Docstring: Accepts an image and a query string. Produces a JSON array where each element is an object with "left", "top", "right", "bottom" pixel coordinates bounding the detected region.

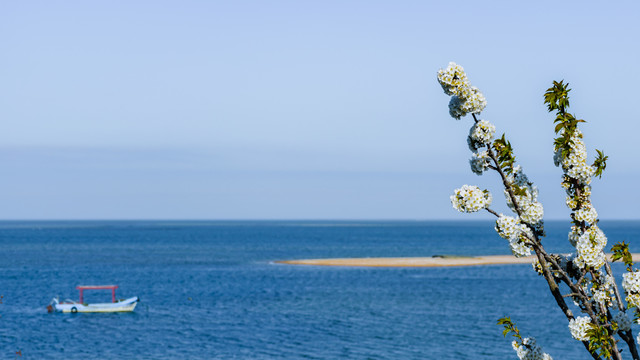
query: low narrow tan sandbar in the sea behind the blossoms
[{"left": 276, "top": 253, "right": 640, "bottom": 267}]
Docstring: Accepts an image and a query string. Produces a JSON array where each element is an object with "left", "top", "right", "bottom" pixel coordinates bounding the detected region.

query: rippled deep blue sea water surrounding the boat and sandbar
[{"left": 0, "top": 221, "right": 640, "bottom": 359}]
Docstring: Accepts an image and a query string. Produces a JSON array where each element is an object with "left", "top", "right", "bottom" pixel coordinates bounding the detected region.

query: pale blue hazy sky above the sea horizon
[{"left": 0, "top": 0, "right": 640, "bottom": 221}]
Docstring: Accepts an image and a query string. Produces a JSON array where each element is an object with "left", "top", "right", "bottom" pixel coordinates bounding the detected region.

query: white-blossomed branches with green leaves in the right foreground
[{"left": 438, "top": 63, "right": 640, "bottom": 360}]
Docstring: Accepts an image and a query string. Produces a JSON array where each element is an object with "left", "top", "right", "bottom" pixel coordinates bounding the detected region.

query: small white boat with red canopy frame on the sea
[{"left": 47, "top": 285, "right": 140, "bottom": 313}]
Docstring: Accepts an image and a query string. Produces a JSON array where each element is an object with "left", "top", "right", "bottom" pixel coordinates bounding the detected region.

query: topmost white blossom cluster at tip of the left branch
[{"left": 438, "top": 62, "right": 487, "bottom": 120}]
